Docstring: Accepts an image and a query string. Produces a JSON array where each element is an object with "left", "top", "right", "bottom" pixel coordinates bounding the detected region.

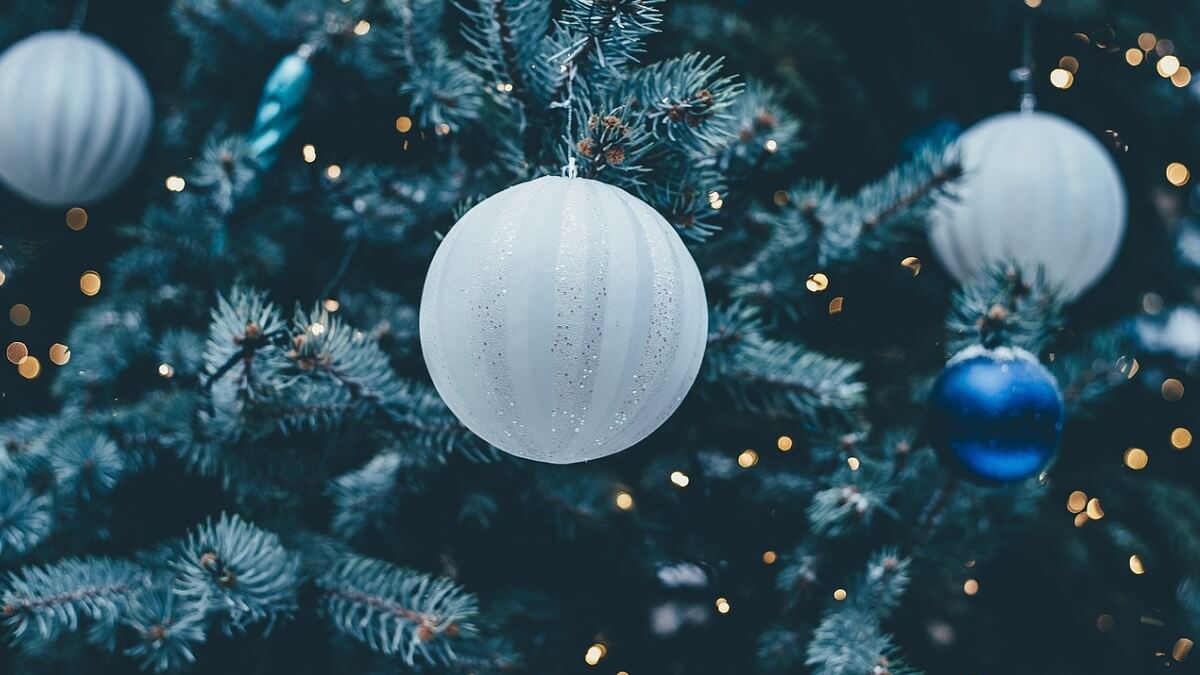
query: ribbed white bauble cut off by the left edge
[{"left": 0, "top": 30, "right": 152, "bottom": 207}]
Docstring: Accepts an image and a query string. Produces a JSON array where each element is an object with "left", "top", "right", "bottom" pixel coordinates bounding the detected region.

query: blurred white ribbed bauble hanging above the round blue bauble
[{"left": 930, "top": 110, "right": 1126, "bottom": 299}]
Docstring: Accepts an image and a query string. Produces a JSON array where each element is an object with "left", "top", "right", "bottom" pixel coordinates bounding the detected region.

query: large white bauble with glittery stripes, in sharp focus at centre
[{"left": 420, "top": 177, "right": 708, "bottom": 464}]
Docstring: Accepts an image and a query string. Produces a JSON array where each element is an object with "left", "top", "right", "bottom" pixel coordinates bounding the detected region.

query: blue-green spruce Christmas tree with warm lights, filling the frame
[{"left": 0, "top": 0, "right": 1200, "bottom": 675}]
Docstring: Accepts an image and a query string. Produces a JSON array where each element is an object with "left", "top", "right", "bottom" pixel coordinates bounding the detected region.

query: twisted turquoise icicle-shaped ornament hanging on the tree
[{"left": 247, "top": 44, "right": 312, "bottom": 168}]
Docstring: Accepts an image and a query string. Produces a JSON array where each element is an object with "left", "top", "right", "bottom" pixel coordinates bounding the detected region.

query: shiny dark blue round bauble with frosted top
[{"left": 926, "top": 347, "right": 1063, "bottom": 484}]
